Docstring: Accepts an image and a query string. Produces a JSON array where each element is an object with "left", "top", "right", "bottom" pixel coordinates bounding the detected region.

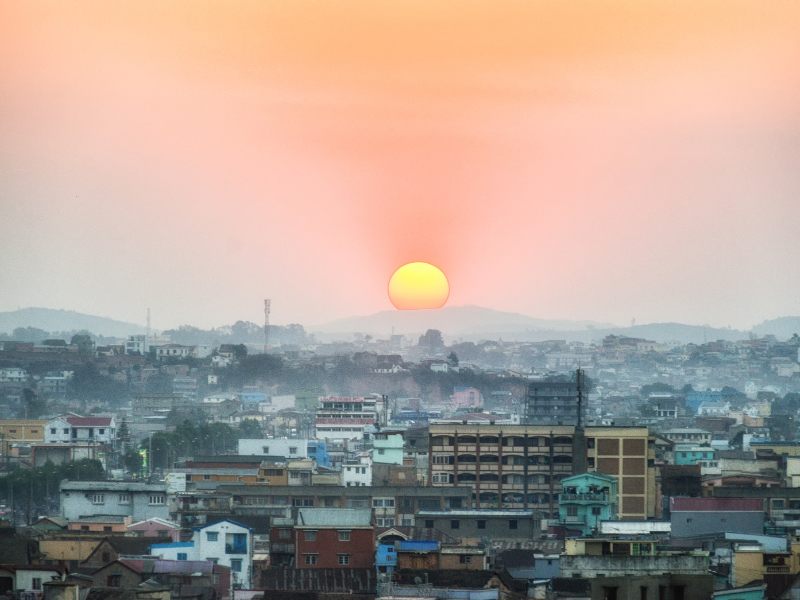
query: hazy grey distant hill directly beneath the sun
[{"left": 307, "top": 306, "right": 614, "bottom": 339}]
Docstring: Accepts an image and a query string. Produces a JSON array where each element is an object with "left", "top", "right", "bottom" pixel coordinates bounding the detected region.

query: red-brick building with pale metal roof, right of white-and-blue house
[{"left": 294, "top": 508, "right": 375, "bottom": 569}]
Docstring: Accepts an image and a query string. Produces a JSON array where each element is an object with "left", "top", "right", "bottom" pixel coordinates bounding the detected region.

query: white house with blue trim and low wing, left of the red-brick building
[{"left": 150, "top": 519, "right": 253, "bottom": 589}]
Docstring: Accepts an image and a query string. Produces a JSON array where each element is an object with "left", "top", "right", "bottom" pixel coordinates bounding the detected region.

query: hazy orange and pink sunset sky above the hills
[{"left": 0, "top": 0, "right": 800, "bottom": 329}]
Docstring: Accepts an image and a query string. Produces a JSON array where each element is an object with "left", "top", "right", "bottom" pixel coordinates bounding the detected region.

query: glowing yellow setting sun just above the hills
[{"left": 389, "top": 262, "right": 450, "bottom": 310}]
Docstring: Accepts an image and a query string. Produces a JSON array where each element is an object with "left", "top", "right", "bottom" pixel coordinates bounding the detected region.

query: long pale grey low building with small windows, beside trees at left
[{"left": 59, "top": 481, "right": 169, "bottom": 521}]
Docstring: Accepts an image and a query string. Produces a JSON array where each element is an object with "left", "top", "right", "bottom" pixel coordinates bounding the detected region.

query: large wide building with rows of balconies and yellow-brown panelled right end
[{"left": 428, "top": 423, "right": 656, "bottom": 520}]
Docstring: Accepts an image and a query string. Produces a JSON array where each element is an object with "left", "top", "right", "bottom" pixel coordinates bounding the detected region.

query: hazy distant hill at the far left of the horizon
[{"left": 0, "top": 308, "right": 146, "bottom": 341}]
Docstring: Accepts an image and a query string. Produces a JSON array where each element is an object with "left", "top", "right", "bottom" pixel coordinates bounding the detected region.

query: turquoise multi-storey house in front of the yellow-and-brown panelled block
[{"left": 558, "top": 473, "right": 617, "bottom": 535}]
